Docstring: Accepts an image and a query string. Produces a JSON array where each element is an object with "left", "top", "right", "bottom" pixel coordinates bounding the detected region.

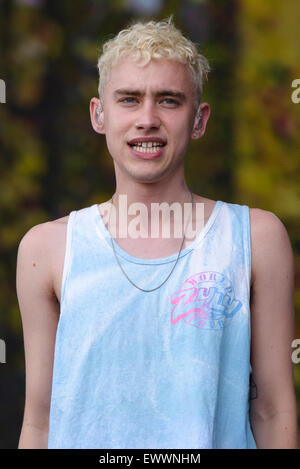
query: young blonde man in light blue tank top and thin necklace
[{"left": 17, "top": 21, "right": 297, "bottom": 449}]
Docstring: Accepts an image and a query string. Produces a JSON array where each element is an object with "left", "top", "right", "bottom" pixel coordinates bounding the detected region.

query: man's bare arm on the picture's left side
[{"left": 16, "top": 222, "right": 60, "bottom": 449}]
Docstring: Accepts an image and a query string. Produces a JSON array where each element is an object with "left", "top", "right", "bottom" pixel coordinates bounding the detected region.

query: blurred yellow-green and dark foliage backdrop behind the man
[{"left": 0, "top": 0, "right": 300, "bottom": 448}]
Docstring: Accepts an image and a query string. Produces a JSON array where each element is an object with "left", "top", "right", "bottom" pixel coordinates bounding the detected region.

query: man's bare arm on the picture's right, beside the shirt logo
[{"left": 250, "top": 209, "right": 299, "bottom": 449}]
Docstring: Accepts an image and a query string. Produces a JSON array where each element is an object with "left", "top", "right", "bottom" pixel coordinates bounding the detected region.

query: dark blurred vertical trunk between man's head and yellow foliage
[{"left": 181, "top": 0, "right": 239, "bottom": 202}]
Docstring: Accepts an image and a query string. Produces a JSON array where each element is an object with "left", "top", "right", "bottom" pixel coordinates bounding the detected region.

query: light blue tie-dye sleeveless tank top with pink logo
[{"left": 48, "top": 201, "right": 256, "bottom": 449}]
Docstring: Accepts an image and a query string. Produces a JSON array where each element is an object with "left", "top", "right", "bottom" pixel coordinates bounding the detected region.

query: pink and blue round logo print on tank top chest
[{"left": 171, "top": 271, "right": 242, "bottom": 329}]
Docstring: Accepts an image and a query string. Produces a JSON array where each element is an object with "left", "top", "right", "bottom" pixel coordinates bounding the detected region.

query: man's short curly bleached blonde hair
[{"left": 98, "top": 15, "right": 210, "bottom": 109}]
